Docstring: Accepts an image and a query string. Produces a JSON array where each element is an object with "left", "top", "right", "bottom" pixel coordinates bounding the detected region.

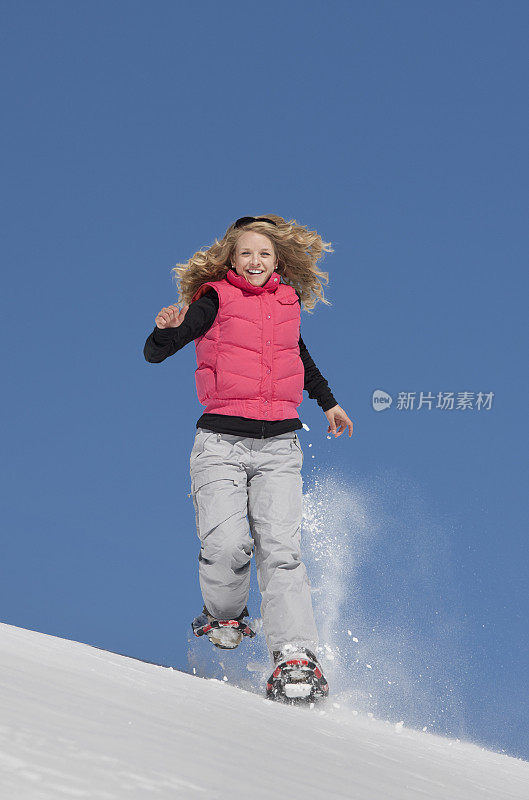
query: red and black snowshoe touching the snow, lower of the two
[{"left": 266, "top": 646, "right": 329, "bottom": 705}]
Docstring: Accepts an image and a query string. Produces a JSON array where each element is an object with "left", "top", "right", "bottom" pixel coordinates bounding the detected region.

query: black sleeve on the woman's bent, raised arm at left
[{"left": 143, "top": 289, "right": 219, "bottom": 364}]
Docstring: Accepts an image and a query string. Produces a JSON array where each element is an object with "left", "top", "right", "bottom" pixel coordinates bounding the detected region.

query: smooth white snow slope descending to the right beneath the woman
[{"left": 0, "top": 624, "right": 529, "bottom": 800}]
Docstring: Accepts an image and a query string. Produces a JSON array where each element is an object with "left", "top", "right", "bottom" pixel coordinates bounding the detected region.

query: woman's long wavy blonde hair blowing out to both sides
[{"left": 171, "top": 214, "right": 334, "bottom": 313}]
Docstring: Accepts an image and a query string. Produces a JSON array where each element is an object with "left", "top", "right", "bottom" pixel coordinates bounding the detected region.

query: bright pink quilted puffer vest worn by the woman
[{"left": 192, "top": 269, "right": 305, "bottom": 420}]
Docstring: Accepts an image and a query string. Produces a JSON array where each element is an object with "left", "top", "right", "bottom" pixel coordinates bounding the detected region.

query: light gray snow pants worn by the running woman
[{"left": 189, "top": 428, "right": 318, "bottom": 654}]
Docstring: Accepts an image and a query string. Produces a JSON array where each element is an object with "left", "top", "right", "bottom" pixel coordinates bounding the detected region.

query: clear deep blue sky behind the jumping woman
[{"left": 0, "top": 0, "right": 529, "bottom": 758}]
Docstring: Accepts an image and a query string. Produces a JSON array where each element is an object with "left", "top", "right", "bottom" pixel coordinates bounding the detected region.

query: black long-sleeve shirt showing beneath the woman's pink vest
[{"left": 143, "top": 289, "right": 338, "bottom": 439}]
